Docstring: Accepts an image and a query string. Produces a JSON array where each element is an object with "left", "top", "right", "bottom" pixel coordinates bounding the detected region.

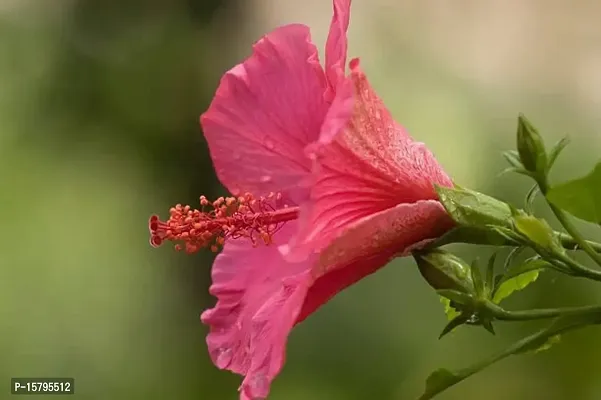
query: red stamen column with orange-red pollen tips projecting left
[{"left": 148, "top": 193, "right": 299, "bottom": 253}]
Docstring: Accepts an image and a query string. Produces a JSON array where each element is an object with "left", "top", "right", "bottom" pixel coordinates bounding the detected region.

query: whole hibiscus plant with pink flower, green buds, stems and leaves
[{"left": 149, "top": 0, "right": 601, "bottom": 400}]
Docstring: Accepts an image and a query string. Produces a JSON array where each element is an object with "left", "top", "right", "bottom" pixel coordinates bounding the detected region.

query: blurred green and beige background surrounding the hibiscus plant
[{"left": 0, "top": 0, "right": 601, "bottom": 400}]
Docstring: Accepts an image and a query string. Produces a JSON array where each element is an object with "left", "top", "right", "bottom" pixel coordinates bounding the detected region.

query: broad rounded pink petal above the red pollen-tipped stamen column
[{"left": 200, "top": 24, "right": 328, "bottom": 195}]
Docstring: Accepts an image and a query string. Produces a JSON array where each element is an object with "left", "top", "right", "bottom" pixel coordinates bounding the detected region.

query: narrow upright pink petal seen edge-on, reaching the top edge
[{"left": 326, "top": 0, "right": 351, "bottom": 89}]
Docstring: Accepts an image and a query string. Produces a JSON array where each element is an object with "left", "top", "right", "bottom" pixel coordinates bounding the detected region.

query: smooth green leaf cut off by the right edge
[{"left": 547, "top": 162, "right": 601, "bottom": 224}]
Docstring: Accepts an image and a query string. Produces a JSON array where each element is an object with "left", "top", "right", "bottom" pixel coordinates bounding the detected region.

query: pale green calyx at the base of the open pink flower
[{"left": 435, "top": 186, "right": 512, "bottom": 228}]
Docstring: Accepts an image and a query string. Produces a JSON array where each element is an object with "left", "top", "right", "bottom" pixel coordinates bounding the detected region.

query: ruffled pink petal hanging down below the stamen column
[{"left": 201, "top": 222, "right": 313, "bottom": 399}]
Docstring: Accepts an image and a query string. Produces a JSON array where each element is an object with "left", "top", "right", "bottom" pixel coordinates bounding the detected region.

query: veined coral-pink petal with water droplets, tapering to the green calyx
[{"left": 281, "top": 60, "right": 452, "bottom": 261}]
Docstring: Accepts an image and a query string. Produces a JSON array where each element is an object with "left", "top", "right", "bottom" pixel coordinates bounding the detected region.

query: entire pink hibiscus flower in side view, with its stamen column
[{"left": 149, "top": 0, "right": 453, "bottom": 400}]
